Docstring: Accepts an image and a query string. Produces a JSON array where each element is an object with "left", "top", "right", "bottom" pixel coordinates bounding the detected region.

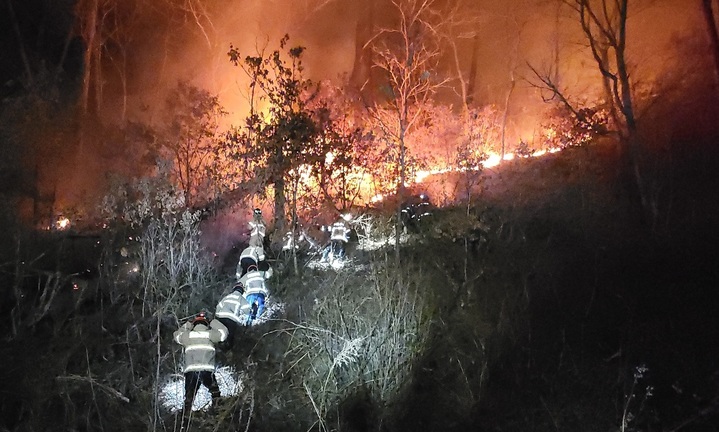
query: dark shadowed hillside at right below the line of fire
[{"left": 396, "top": 138, "right": 719, "bottom": 431}]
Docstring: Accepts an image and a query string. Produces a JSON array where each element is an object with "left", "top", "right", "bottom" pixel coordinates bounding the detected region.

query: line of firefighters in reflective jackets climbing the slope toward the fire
[{"left": 169, "top": 209, "right": 349, "bottom": 431}]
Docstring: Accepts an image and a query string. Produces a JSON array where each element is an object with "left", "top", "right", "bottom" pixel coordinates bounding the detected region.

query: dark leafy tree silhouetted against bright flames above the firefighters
[{"left": 229, "top": 36, "right": 380, "bottom": 243}]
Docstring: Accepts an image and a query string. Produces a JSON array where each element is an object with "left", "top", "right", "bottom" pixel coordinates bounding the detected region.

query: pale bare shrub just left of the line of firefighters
[{"left": 100, "top": 164, "right": 217, "bottom": 315}]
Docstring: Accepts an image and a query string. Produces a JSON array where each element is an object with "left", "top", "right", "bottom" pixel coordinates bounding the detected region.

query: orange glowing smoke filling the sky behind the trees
[{"left": 101, "top": 0, "right": 698, "bottom": 133}]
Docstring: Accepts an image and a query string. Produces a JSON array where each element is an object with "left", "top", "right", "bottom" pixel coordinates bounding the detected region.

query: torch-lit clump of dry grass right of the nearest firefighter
[{"left": 285, "top": 263, "right": 431, "bottom": 431}]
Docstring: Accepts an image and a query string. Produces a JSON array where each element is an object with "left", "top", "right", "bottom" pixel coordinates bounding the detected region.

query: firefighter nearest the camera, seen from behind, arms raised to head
[{"left": 174, "top": 312, "right": 227, "bottom": 430}]
